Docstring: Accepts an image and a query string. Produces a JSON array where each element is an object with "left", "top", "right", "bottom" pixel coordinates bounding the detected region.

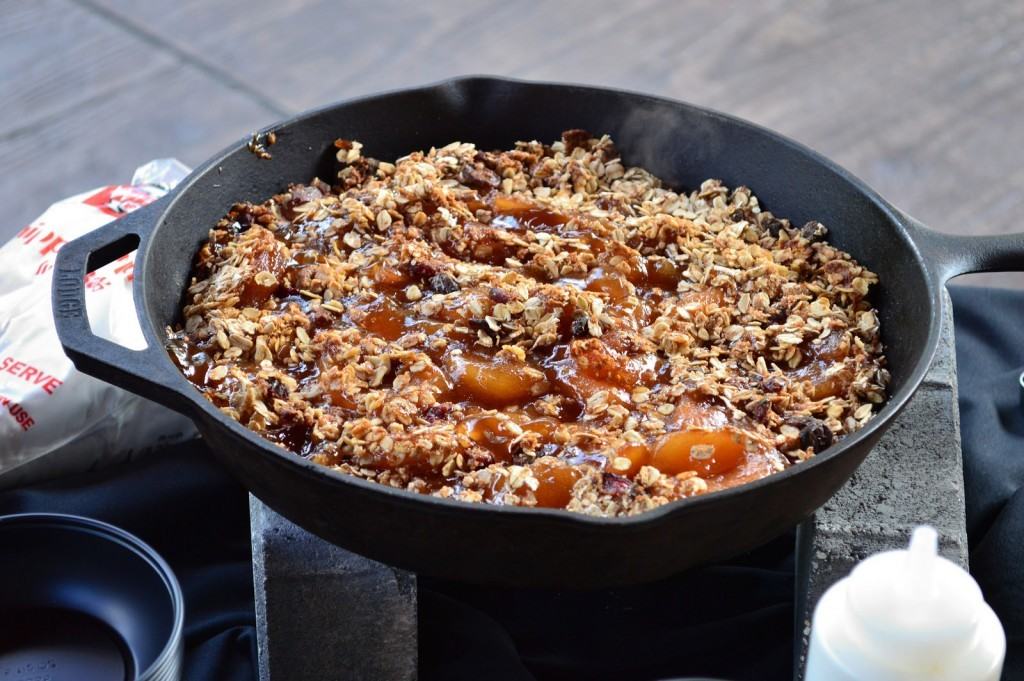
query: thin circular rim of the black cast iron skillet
[{"left": 64, "top": 76, "right": 944, "bottom": 528}]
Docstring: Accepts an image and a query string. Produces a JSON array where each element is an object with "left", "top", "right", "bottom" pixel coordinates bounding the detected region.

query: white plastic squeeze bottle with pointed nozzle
[{"left": 804, "top": 527, "right": 1007, "bottom": 681}]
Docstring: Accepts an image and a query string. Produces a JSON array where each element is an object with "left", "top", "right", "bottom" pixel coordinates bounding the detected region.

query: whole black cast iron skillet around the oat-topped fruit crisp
[{"left": 53, "top": 78, "right": 1024, "bottom": 587}]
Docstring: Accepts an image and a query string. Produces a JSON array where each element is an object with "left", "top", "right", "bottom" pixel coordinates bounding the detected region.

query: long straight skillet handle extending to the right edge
[{"left": 911, "top": 220, "right": 1024, "bottom": 283}]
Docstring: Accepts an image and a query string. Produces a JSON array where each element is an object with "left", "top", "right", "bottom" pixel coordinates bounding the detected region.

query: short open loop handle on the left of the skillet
[{"left": 51, "top": 197, "right": 193, "bottom": 412}]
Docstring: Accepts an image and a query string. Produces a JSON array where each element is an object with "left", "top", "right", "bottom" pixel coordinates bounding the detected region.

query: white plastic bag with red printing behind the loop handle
[{"left": 0, "top": 159, "right": 196, "bottom": 487}]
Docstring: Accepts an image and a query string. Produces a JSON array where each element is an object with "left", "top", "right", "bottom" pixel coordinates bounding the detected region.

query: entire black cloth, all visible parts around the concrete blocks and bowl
[{"left": 0, "top": 289, "right": 1024, "bottom": 681}]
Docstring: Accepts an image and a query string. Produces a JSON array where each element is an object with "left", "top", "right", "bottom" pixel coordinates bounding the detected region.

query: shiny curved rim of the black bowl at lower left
[{"left": 0, "top": 513, "right": 185, "bottom": 681}]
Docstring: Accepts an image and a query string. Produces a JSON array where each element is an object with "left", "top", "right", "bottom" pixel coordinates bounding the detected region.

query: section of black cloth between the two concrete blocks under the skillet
[{"left": 420, "top": 533, "right": 795, "bottom": 681}]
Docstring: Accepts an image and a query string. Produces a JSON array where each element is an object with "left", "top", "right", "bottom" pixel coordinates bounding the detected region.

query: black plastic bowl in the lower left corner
[{"left": 0, "top": 513, "right": 184, "bottom": 681}]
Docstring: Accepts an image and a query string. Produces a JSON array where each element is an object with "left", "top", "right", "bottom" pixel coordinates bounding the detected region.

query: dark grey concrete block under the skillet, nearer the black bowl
[{"left": 249, "top": 497, "right": 417, "bottom": 681}]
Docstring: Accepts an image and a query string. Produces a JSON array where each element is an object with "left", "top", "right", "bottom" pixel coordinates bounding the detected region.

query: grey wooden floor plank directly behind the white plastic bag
[{"left": 0, "top": 65, "right": 276, "bottom": 238}]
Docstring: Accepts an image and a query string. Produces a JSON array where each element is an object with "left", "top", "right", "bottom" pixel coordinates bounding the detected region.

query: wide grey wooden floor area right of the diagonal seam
[{"left": 16, "top": 0, "right": 1024, "bottom": 286}]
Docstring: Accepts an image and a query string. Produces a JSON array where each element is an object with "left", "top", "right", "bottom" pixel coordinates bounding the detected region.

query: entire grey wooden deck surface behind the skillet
[{"left": 0, "top": 0, "right": 1024, "bottom": 287}]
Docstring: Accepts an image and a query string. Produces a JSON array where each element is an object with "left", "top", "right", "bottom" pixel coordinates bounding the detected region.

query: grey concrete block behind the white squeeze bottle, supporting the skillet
[{"left": 795, "top": 295, "right": 968, "bottom": 678}]
